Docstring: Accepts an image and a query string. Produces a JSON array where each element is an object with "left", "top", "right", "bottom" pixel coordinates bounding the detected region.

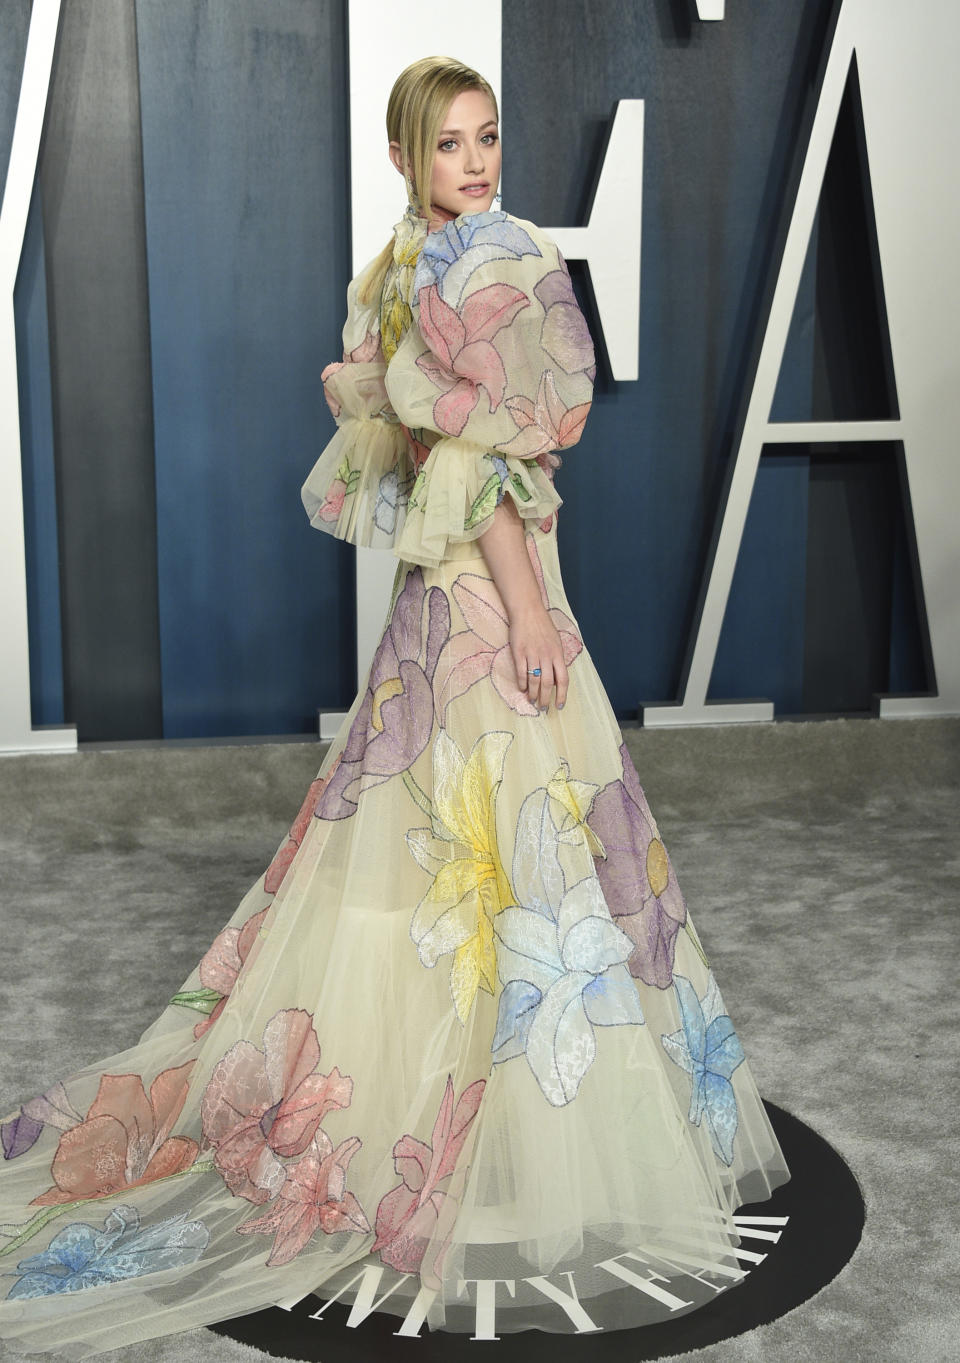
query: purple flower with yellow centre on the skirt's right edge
[{"left": 588, "top": 744, "right": 687, "bottom": 990}]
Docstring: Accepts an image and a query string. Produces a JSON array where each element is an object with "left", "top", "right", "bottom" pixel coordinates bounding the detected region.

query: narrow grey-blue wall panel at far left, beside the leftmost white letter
[{"left": 40, "top": 0, "right": 161, "bottom": 740}]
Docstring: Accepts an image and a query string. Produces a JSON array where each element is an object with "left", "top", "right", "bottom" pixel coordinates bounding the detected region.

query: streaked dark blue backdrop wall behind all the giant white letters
[{"left": 0, "top": 0, "right": 923, "bottom": 737}]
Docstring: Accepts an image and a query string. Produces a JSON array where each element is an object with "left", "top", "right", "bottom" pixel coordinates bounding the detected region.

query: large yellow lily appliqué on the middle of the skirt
[{"left": 406, "top": 729, "right": 514, "bottom": 1022}]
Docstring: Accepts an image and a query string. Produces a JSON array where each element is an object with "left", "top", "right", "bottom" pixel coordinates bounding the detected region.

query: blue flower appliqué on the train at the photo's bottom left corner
[{"left": 7, "top": 1206, "right": 210, "bottom": 1299}]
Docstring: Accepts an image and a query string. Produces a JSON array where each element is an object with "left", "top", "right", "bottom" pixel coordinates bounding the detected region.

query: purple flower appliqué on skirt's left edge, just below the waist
[{"left": 316, "top": 568, "right": 450, "bottom": 819}]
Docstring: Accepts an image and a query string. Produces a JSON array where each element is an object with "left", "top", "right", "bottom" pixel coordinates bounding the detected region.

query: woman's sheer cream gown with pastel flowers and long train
[{"left": 0, "top": 201, "right": 790, "bottom": 1358}]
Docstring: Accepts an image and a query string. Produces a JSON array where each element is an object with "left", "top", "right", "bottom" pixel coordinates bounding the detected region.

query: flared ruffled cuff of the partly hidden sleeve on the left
[{"left": 300, "top": 413, "right": 413, "bottom": 549}]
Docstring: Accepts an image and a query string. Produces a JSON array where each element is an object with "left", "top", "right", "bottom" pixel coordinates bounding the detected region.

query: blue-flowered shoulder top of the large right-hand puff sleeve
[{"left": 413, "top": 210, "right": 565, "bottom": 307}]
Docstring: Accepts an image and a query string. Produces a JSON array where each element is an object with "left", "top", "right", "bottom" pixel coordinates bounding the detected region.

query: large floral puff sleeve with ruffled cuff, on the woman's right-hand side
[{"left": 386, "top": 211, "right": 596, "bottom": 567}]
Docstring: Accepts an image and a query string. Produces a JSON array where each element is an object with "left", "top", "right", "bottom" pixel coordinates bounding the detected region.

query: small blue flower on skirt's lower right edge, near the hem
[{"left": 660, "top": 972, "right": 745, "bottom": 1164}]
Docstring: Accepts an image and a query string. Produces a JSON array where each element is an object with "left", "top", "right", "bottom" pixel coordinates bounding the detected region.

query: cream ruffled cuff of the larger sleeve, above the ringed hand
[{"left": 394, "top": 436, "right": 562, "bottom": 568}]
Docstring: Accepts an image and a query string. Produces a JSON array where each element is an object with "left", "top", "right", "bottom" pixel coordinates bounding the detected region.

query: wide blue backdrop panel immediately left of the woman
[{"left": 138, "top": 0, "right": 356, "bottom": 737}]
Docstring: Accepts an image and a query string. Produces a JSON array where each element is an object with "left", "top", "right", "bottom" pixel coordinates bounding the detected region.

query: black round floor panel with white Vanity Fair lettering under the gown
[{"left": 210, "top": 1103, "right": 865, "bottom": 1363}]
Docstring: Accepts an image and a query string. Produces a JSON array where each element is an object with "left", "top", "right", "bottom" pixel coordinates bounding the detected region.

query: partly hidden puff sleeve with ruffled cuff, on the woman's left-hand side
[{"left": 300, "top": 273, "right": 413, "bottom": 549}]
